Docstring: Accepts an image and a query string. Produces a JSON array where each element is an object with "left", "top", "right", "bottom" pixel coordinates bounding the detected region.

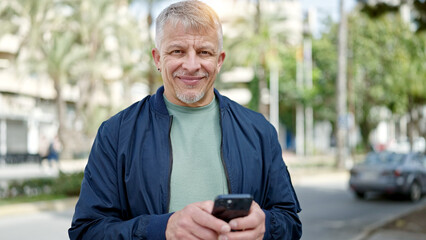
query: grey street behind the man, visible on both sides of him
[{"left": 0, "top": 170, "right": 426, "bottom": 240}]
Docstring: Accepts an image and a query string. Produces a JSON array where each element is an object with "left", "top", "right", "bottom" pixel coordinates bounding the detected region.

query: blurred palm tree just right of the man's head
[{"left": 225, "top": 0, "right": 288, "bottom": 115}]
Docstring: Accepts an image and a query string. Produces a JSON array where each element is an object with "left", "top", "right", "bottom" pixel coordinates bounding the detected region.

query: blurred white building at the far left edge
[{"left": 0, "top": 34, "right": 57, "bottom": 163}]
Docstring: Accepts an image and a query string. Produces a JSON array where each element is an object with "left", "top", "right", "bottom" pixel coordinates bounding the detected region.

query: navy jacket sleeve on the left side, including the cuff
[{"left": 68, "top": 122, "right": 171, "bottom": 240}]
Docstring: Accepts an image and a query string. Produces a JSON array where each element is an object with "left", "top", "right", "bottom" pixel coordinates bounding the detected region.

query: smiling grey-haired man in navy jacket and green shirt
[{"left": 69, "top": 0, "right": 301, "bottom": 239}]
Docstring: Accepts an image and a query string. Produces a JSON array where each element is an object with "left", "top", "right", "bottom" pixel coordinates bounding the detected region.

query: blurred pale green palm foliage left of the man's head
[{"left": 0, "top": 0, "right": 151, "bottom": 152}]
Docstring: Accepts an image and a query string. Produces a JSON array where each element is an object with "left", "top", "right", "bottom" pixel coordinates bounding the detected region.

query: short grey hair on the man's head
[{"left": 155, "top": 0, "right": 223, "bottom": 52}]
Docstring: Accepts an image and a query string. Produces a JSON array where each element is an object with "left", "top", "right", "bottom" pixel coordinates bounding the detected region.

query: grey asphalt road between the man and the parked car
[{"left": 294, "top": 173, "right": 426, "bottom": 240}]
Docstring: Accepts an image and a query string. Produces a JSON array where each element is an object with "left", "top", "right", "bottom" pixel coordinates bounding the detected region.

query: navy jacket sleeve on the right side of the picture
[{"left": 262, "top": 124, "right": 302, "bottom": 240}]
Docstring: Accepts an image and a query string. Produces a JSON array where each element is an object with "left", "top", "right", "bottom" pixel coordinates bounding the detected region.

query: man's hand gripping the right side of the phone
[{"left": 219, "top": 201, "right": 265, "bottom": 240}]
